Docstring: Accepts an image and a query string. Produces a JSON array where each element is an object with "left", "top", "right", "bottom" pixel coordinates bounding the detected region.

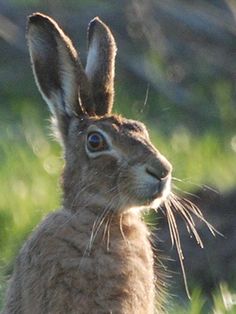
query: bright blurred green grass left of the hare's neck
[{"left": 0, "top": 101, "right": 62, "bottom": 264}]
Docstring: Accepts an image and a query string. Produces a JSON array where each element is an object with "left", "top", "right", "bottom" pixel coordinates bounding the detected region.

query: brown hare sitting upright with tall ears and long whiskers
[{"left": 3, "top": 13, "right": 216, "bottom": 314}]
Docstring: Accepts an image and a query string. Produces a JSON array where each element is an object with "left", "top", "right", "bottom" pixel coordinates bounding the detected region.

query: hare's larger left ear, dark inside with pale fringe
[{"left": 27, "top": 13, "right": 94, "bottom": 141}]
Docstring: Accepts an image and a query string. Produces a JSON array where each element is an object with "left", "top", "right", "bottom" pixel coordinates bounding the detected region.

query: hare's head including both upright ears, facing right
[{"left": 27, "top": 13, "right": 171, "bottom": 213}]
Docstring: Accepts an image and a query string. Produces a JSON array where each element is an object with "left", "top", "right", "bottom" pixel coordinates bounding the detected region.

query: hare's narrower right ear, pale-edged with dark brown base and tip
[{"left": 85, "top": 17, "right": 116, "bottom": 115}]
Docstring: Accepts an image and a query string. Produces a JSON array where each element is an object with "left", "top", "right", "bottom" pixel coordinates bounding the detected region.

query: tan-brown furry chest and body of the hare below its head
[{"left": 17, "top": 211, "right": 154, "bottom": 314}]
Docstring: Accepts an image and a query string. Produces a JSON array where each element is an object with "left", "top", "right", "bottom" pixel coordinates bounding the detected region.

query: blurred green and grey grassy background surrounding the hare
[{"left": 0, "top": 0, "right": 236, "bottom": 314}]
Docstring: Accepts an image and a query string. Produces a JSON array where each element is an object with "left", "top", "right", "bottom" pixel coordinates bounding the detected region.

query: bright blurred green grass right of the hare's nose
[{"left": 151, "top": 128, "right": 236, "bottom": 192}]
